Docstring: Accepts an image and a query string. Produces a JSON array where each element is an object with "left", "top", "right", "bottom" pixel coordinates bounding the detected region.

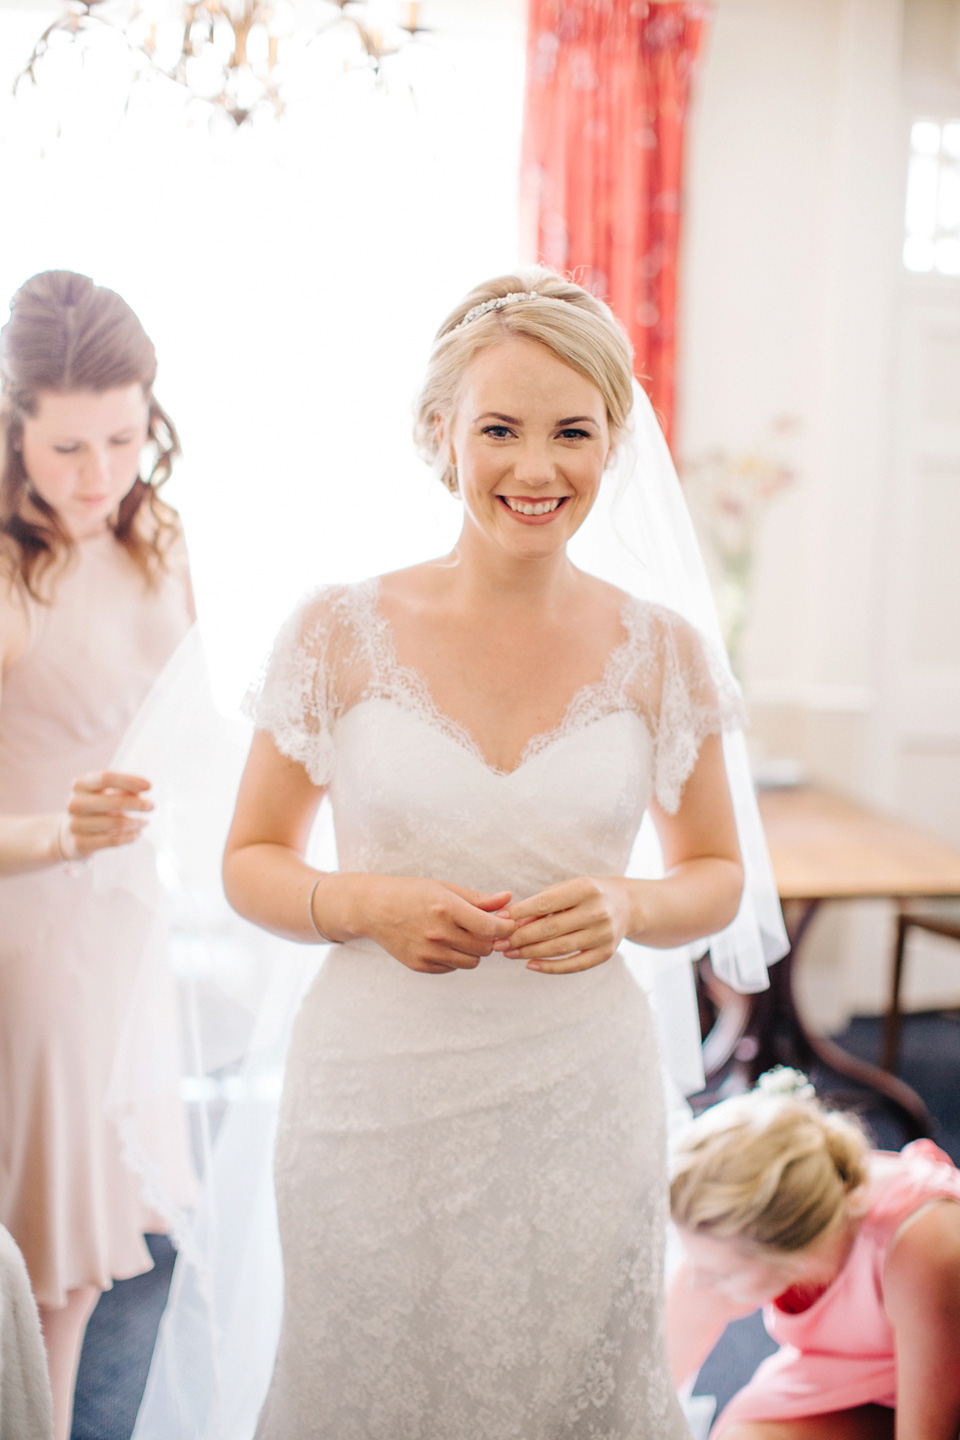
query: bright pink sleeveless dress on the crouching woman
[{"left": 710, "top": 1140, "right": 960, "bottom": 1440}]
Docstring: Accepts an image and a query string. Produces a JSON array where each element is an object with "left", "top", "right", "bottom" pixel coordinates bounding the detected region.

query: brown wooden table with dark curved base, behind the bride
[{"left": 704, "top": 785, "right": 960, "bottom": 1136}]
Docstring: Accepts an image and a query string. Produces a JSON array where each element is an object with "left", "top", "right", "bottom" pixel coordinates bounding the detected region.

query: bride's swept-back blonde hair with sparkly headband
[{"left": 413, "top": 268, "right": 633, "bottom": 494}]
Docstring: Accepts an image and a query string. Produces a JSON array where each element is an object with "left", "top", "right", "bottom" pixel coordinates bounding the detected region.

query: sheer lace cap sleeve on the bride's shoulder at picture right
[{"left": 638, "top": 605, "right": 747, "bottom": 815}]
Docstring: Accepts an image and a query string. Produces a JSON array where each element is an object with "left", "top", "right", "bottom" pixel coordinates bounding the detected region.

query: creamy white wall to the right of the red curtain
[{"left": 679, "top": 0, "right": 960, "bottom": 1024}]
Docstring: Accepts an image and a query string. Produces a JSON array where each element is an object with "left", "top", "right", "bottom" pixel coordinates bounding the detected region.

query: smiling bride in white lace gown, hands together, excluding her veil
[{"left": 225, "top": 271, "right": 743, "bottom": 1440}]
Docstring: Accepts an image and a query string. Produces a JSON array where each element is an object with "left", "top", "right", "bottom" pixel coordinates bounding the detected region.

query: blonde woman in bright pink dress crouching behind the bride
[{"left": 668, "top": 1070, "right": 960, "bottom": 1440}]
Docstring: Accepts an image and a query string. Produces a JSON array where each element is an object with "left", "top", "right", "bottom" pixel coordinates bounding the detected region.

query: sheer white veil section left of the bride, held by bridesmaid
[{"left": 95, "top": 626, "right": 326, "bottom": 1440}]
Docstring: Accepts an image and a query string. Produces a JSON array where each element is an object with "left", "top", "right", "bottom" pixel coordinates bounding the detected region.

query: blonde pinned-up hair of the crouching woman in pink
[{"left": 671, "top": 1071, "right": 869, "bottom": 1253}]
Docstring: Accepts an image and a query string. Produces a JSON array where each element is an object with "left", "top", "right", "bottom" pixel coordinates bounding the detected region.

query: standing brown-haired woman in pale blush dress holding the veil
[{"left": 0, "top": 271, "right": 193, "bottom": 1440}]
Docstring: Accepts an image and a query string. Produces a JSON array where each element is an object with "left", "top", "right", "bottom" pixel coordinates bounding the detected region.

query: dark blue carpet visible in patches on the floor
[{"left": 72, "top": 1012, "right": 960, "bottom": 1440}]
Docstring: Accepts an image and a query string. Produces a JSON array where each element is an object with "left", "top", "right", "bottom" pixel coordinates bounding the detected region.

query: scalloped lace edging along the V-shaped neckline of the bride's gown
[{"left": 361, "top": 575, "right": 639, "bottom": 779}]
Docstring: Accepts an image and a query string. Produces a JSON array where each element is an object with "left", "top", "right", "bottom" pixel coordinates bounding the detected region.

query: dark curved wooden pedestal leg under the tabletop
[{"left": 711, "top": 900, "right": 934, "bottom": 1139}]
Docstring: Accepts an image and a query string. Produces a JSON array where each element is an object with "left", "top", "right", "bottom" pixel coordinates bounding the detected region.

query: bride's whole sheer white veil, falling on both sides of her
[{"left": 108, "top": 386, "right": 787, "bottom": 1440}]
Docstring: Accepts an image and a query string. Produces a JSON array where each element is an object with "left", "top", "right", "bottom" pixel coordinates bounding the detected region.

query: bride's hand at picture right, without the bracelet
[{"left": 495, "top": 876, "right": 639, "bottom": 975}]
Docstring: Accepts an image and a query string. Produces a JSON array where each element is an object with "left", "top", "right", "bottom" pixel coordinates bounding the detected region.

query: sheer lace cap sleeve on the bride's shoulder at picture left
[{"left": 242, "top": 580, "right": 376, "bottom": 786}]
